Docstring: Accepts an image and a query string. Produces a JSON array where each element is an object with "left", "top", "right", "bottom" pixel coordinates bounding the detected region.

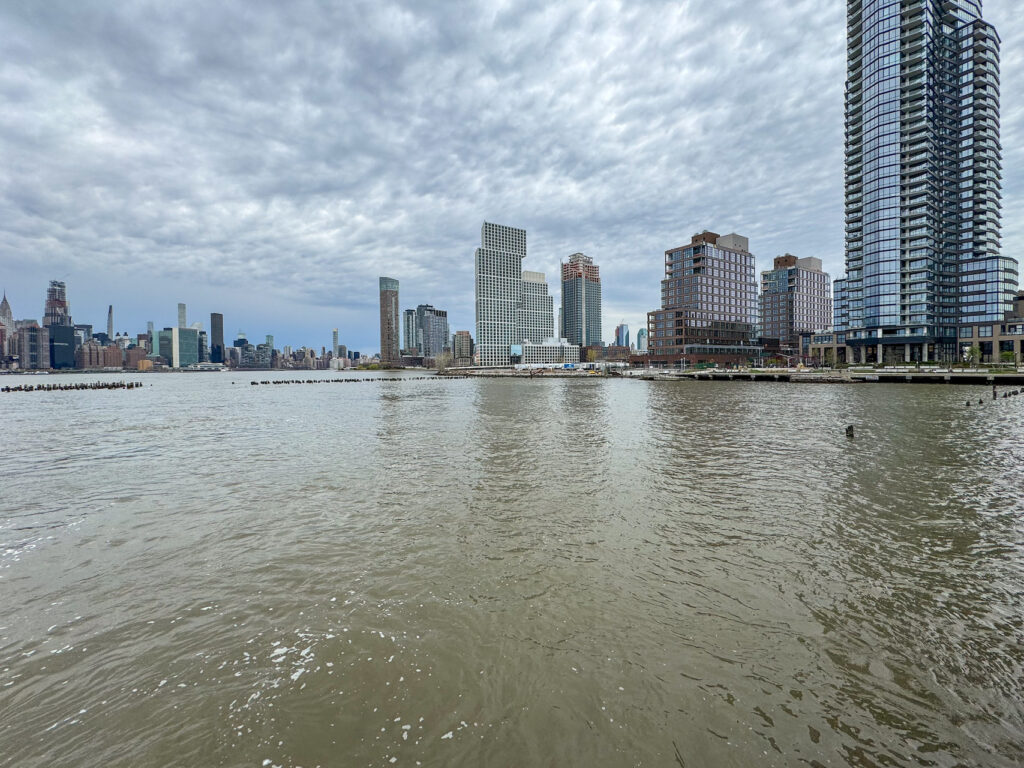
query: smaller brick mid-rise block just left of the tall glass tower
[{"left": 759, "top": 253, "right": 833, "bottom": 347}]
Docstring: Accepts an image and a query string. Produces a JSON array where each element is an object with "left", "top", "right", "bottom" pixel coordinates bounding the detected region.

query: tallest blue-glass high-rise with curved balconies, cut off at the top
[{"left": 835, "top": 0, "right": 1017, "bottom": 362}]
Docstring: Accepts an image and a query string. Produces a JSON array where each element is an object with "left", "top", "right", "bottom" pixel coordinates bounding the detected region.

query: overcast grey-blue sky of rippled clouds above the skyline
[{"left": 0, "top": 0, "right": 1024, "bottom": 352}]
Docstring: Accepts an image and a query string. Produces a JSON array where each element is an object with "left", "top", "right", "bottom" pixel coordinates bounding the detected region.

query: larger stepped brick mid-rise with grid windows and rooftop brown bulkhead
[{"left": 647, "top": 229, "right": 760, "bottom": 366}]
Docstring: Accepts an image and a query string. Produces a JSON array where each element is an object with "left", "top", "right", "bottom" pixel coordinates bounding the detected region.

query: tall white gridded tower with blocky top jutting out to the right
[{"left": 473, "top": 221, "right": 526, "bottom": 366}]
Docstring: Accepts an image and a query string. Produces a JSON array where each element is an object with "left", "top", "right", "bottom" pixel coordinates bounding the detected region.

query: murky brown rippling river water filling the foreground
[{"left": 0, "top": 374, "right": 1024, "bottom": 768}]
